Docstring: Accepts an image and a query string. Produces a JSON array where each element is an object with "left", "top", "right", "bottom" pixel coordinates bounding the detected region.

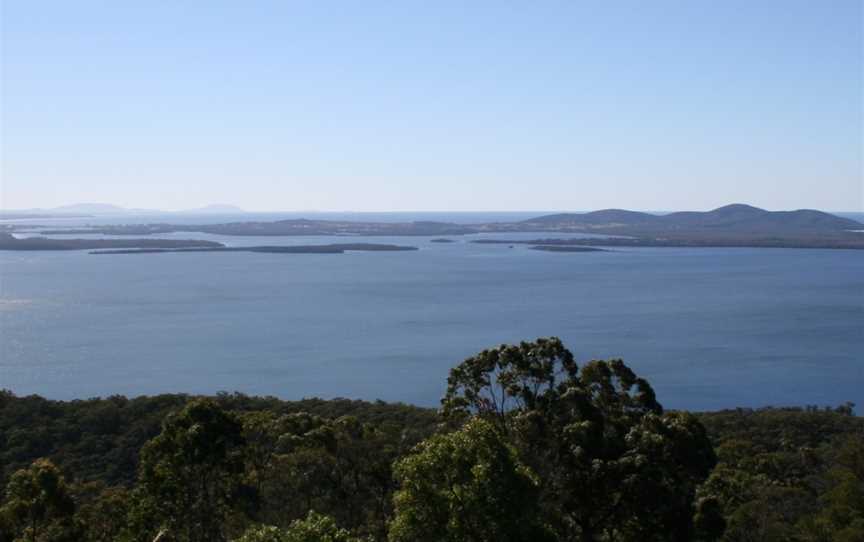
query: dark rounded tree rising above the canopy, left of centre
[{"left": 136, "top": 399, "right": 244, "bottom": 542}]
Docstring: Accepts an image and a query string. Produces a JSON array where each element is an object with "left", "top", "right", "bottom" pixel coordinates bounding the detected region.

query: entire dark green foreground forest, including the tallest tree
[{"left": 0, "top": 338, "right": 864, "bottom": 542}]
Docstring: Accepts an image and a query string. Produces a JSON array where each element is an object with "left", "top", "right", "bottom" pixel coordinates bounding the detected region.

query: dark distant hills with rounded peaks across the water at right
[{"left": 522, "top": 203, "right": 862, "bottom": 233}]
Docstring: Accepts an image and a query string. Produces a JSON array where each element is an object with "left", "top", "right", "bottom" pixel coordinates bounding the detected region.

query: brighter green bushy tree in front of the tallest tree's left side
[{"left": 389, "top": 419, "right": 550, "bottom": 542}]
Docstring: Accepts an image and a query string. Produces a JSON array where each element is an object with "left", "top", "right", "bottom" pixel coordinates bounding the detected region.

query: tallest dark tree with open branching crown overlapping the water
[{"left": 442, "top": 338, "right": 715, "bottom": 541}]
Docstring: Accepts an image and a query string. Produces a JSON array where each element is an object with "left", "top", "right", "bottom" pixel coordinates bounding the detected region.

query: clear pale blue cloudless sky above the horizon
[{"left": 0, "top": 0, "right": 864, "bottom": 211}]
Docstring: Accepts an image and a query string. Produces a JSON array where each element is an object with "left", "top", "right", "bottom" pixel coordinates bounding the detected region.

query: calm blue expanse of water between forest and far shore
[{"left": 0, "top": 215, "right": 864, "bottom": 411}]
